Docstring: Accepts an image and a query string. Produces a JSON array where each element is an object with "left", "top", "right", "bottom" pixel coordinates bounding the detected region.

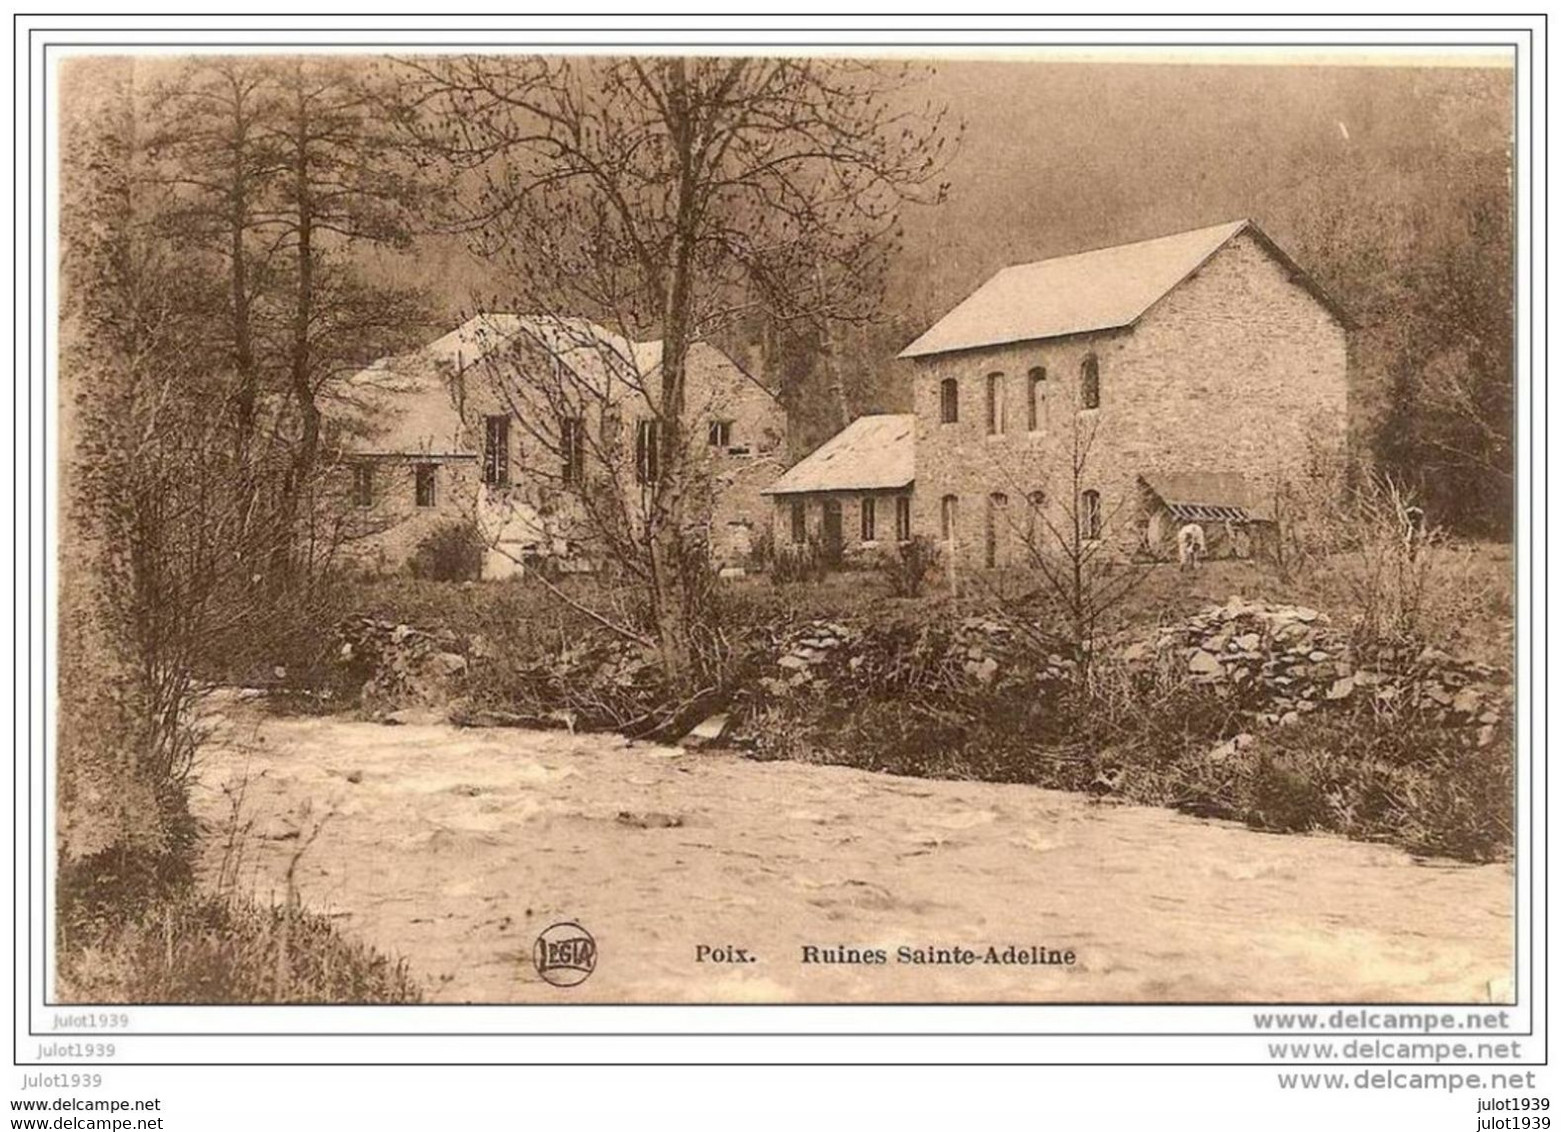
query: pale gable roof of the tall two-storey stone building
[{"left": 899, "top": 220, "right": 1349, "bottom": 358}]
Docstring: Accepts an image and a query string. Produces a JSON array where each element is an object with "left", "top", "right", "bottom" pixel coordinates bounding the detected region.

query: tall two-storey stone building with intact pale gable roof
[{"left": 761, "top": 220, "right": 1349, "bottom": 568}]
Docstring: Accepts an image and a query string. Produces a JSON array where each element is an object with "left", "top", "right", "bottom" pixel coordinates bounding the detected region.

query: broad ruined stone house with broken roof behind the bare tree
[{"left": 340, "top": 314, "right": 785, "bottom": 578}]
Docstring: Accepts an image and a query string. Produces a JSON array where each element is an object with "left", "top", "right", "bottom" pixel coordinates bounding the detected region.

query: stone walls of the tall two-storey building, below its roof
[{"left": 913, "top": 234, "right": 1347, "bottom": 567}]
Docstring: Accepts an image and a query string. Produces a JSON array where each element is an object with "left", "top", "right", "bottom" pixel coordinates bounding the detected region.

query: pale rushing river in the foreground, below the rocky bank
[{"left": 194, "top": 706, "right": 1513, "bottom": 1002}]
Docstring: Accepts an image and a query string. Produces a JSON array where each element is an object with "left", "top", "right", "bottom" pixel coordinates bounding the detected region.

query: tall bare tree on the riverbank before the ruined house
[{"left": 393, "top": 56, "right": 948, "bottom": 687}]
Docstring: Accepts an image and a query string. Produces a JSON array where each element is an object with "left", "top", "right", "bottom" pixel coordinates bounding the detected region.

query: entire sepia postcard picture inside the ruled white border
[{"left": 45, "top": 44, "right": 1511, "bottom": 1005}]
